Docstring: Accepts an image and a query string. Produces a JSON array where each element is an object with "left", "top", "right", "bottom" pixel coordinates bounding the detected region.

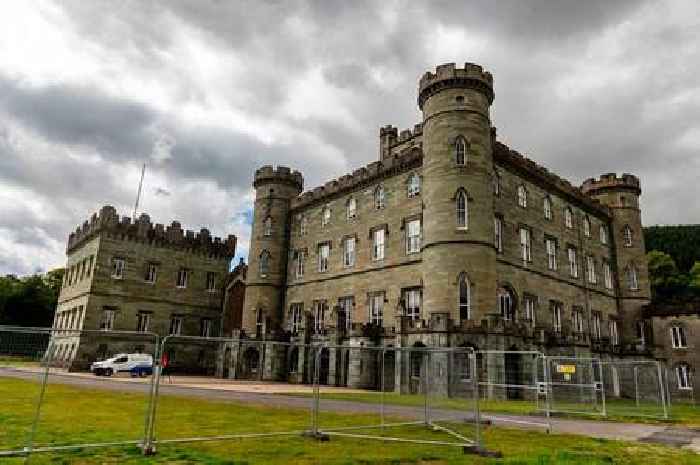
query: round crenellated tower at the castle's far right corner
[{"left": 581, "top": 173, "right": 651, "bottom": 345}]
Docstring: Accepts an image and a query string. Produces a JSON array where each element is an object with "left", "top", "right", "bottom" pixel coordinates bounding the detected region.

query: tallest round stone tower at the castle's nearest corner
[{"left": 418, "top": 63, "right": 497, "bottom": 322}]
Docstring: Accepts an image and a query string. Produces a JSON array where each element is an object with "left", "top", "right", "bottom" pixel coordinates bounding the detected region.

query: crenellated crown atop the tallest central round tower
[{"left": 418, "top": 63, "right": 495, "bottom": 110}]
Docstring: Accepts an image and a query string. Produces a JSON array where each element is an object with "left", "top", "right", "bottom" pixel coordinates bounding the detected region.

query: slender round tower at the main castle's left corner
[{"left": 242, "top": 166, "right": 304, "bottom": 337}]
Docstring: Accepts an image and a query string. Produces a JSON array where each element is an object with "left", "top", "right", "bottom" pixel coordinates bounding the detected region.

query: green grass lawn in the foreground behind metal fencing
[{"left": 0, "top": 378, "right": 700, "bottom": 465}]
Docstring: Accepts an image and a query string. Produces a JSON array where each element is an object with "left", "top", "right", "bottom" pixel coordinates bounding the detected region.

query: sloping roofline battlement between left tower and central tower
[{"left": 292, "top": 147, "right": 423, "bottom": 209}]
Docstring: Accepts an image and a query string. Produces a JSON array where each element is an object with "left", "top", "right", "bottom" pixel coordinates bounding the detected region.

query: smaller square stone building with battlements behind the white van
[{"left": 53, "top": 206, "right": 236, "bottom": 374}]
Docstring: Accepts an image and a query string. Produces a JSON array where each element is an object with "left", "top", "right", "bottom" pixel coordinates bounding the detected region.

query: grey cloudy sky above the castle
[{"left": 0, "top": 0, "right": 700, "bottom": 274}]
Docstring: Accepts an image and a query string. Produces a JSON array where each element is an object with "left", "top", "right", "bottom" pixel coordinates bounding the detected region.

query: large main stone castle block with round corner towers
[{"left": 230, "top": 63, "right": 650, "bottom": 396}]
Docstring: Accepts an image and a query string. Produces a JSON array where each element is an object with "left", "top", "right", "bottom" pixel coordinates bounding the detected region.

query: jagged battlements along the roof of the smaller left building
[{"left": 66, "top": 205, "right": 236, "bottom": 259}]
